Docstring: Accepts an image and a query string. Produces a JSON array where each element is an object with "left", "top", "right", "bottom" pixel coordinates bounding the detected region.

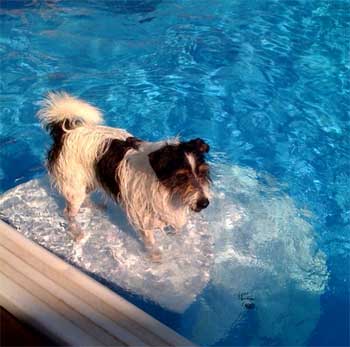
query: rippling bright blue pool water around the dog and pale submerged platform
[{"left": 0, "top": 0, "right": 350, "bottom": 346}]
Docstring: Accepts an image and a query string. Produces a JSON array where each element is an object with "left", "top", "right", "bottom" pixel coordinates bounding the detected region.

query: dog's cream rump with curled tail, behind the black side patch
[{"left": 38, "top": 93, "right": 131, "bottom": 200}]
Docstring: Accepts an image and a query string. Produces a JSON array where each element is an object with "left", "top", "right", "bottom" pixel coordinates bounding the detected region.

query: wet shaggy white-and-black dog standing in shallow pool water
[{"left": 37, "top": 93, "right": 211, "bottom": 248}]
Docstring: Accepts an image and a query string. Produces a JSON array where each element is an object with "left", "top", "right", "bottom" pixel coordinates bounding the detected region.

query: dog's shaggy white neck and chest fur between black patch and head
[{"left": 116, "top": 140, "right": 188, "bottom": 244}]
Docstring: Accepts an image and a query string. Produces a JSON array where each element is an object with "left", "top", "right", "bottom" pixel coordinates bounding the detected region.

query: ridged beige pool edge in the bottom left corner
[{"left": 0, "top": 221, "right": 194, "bottom": 346}]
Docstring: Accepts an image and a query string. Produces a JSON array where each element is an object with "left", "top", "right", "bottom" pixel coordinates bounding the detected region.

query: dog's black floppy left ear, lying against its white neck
[{"left": 148, "top": 146, "right": 174, "bottom": 180}]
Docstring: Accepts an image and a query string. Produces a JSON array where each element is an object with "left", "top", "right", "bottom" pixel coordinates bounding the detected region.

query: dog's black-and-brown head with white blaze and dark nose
[{"left": 149, "top": 138, "right": 210, "bottom": 212}]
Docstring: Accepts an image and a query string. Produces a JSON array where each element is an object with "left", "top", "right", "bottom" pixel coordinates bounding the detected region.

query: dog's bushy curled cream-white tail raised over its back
[{"left": 37, "top": 92, "right": 102, "bottom": 131}]
